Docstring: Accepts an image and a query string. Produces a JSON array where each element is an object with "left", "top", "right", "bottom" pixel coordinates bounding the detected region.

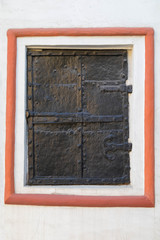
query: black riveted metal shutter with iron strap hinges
[{"left": 26, "top": 49, "right": 132, "bottom": 185}]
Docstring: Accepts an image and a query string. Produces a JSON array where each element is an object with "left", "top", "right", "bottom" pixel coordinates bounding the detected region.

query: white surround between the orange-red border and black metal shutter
[{"left": 14, "top": 36, "right": 145, "bottom": 196}]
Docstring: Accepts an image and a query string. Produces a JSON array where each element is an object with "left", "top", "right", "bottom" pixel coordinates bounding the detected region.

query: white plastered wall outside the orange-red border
[{"left": 0, "top": 0, "right": 160, "bottom": 240}]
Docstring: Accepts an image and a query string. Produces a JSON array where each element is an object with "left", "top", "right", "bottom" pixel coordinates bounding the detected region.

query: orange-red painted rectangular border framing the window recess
[{"left": 5, "top": 28, "right": 154, "bottom": 207}]
